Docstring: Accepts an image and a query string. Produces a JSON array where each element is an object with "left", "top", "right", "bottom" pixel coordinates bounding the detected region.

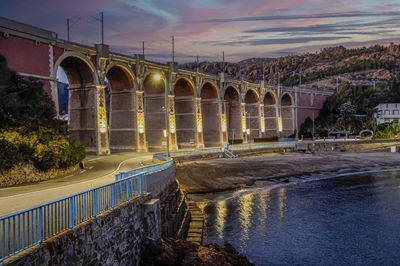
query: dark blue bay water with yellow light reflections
[{"left": 202, "top": 172, "right": 400, "bottom": 265}]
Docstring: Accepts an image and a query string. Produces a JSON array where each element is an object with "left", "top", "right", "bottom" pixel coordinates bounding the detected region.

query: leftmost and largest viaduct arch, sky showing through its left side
[{"left": 56, "top": 56, "right": 97, "bottom": 150}]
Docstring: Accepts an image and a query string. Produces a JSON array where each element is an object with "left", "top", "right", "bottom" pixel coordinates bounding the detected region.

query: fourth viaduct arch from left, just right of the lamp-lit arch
[{"left": 173, "top": 77, "right": 196, "bottom": 148}]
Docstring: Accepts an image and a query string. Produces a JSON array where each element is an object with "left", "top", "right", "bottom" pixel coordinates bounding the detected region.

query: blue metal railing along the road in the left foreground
[{"left": 0, "top": 155, "right": 173, "bottom": 262}]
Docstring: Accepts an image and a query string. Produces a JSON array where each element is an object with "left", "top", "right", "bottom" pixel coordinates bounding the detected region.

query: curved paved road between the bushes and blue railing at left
[{"left": 0, "top": 152, "right": 153, "bottom": 217}]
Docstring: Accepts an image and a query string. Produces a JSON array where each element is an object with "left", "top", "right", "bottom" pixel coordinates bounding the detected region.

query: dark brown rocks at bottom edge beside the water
[{"left": 142, "top": 238, "right": 254, "bottom": 266}]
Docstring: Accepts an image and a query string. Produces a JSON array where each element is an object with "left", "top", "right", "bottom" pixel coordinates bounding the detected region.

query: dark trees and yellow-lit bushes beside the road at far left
[{"left": 0, "top": 55, "right": 85, "bottom": 171}]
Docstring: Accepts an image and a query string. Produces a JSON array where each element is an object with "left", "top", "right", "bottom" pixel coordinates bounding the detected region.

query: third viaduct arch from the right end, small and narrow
[{"left": 244, "top": 89, "right": 260, "bottom": 141}]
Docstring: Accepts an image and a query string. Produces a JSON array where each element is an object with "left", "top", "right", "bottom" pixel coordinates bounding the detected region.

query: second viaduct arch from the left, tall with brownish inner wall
[{"left": 105, "top": 63, "right": 137, "bottom": 150}]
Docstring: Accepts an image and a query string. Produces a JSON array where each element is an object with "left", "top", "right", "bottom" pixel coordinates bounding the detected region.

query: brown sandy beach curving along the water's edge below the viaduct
[{"left": 176, "top": 152, "right": 400, "bottom": 201}]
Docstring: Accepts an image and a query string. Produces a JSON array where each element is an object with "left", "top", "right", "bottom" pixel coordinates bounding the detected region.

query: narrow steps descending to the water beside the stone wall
[{"left": 186, "top": 202, "right": 204, "bottom": 245}]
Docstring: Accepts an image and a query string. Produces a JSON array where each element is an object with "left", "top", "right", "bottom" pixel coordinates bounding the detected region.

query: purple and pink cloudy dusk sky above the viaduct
[{"left": 0, "top": 0, "right": 400, "bottom": 63}]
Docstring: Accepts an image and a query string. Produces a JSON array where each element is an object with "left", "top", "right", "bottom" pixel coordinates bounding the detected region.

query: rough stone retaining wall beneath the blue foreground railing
[{"left": 3, "top": 168, "right": 186, "bottom": 265}]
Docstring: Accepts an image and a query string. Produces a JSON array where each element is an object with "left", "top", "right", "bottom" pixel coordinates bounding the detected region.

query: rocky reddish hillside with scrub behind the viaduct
[{"left": 183, "top": 44, "right": 400, "bottom": 89}]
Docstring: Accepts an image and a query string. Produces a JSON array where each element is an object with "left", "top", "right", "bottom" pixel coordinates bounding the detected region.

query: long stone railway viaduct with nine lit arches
[{"left": 0, "top": 17, "right": 331, "bottom": 154}]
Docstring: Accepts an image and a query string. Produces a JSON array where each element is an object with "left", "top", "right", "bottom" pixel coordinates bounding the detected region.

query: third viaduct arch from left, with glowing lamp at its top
[{"left": 143, "top": 71, "right": 168, "bottom": 151}]
